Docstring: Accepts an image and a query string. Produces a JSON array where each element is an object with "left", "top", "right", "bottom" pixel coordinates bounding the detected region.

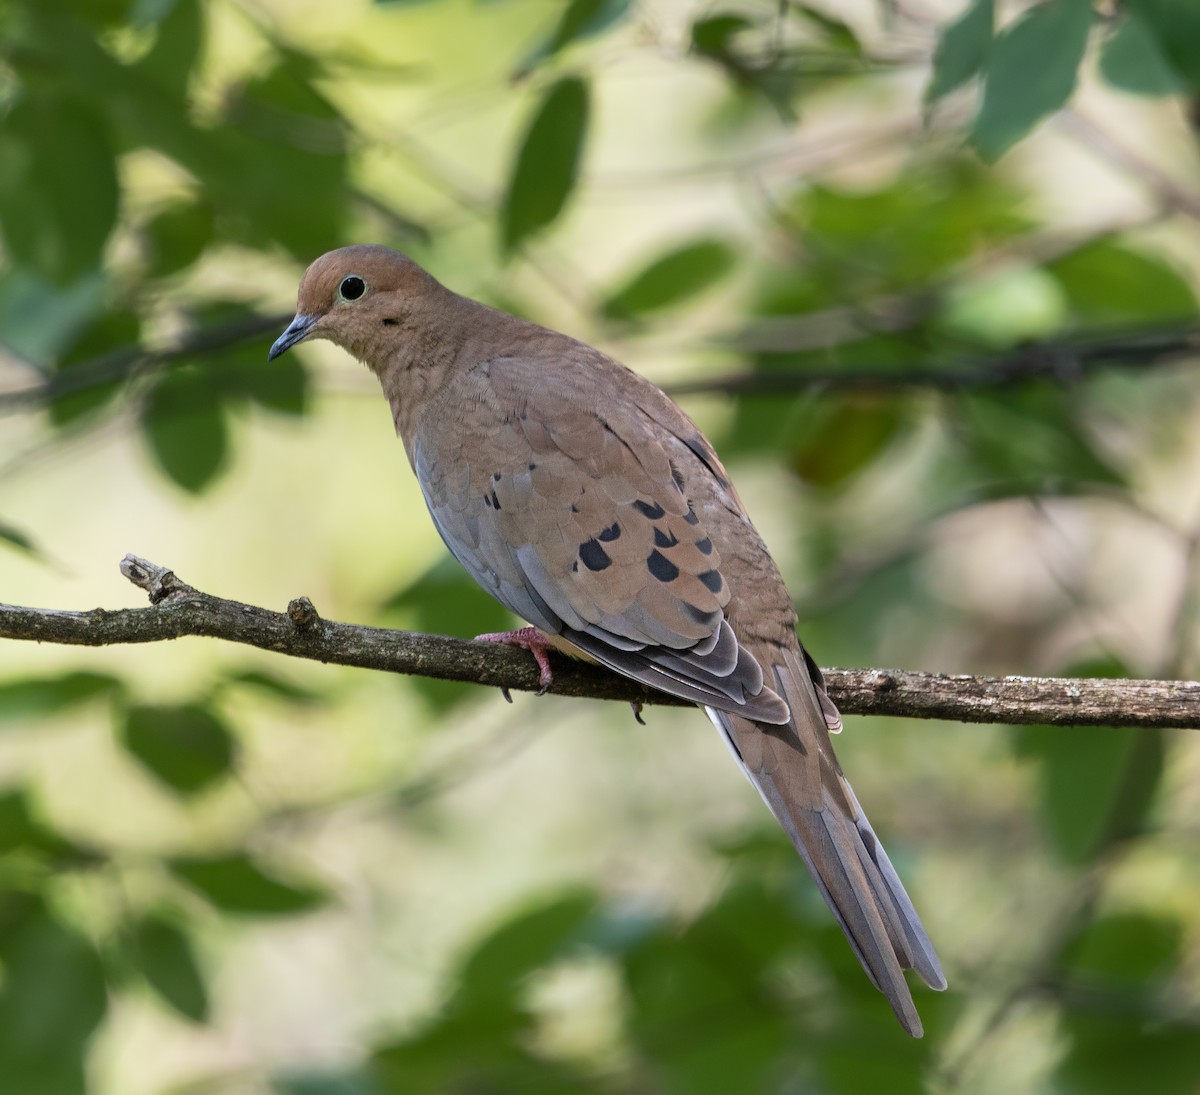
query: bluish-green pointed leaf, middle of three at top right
[{"left": 971, "top": 0, "right": 1092, "bottom": 161}]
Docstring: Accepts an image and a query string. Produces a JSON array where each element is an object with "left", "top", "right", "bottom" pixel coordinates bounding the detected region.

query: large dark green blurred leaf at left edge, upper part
[{"left": 0, "top": 92, "right": 118, "bottom": 286}]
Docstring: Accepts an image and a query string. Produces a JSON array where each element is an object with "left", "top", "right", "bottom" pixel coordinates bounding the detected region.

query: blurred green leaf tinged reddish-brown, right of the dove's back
[{"left": 791, "top": 397, "right": 907, "bottom": 487}]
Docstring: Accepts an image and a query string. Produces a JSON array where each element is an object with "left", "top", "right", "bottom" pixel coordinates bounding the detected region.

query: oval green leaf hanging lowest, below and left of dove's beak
[{"left": 140, "top": 366, "right": 229, "bottom": 493}]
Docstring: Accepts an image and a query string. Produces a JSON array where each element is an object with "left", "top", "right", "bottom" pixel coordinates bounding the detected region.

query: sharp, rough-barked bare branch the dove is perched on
[{"left": 0, "top": 555, "right": 1200, "bottom": 729}]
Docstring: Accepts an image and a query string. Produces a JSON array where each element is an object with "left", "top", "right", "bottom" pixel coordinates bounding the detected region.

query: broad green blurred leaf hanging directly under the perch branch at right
[{"left": 1015, "top": 726, "right": 1163, "bottom": 864}]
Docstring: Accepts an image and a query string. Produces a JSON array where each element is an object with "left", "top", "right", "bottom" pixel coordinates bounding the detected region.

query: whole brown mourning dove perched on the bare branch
[{"left": 270, "top": 246, "right": 946, "bottom": 1037}]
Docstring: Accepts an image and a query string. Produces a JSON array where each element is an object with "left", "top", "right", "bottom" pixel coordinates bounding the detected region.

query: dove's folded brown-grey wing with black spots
[{"left": 413, "top": 359, "right": 787, "bottom": 723}]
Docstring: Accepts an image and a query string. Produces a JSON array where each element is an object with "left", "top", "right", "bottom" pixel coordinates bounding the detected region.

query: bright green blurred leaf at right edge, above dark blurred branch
[{"left": 1045, "top": 239, "right": 1196, "bottom": 327}]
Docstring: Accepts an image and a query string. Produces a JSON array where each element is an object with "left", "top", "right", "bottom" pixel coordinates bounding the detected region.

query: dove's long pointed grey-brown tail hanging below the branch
[{"left": 706, "top": 647, "right": 946, "bottom": 1037}]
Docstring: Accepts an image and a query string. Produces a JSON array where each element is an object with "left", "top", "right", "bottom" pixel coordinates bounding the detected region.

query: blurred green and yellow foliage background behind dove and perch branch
[{"left": 0, "top": 0, "right": 1200, "bottom": 1095}]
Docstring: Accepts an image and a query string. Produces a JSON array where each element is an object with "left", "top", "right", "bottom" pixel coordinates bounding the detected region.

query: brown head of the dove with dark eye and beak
[{"left": 266, "top": 244, "right": 445, "bottom": 365}]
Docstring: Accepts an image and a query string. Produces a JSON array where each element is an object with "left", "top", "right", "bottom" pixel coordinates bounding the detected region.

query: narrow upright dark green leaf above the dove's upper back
[{"left": 500, "top": 76, "right": 588, "bottom": 255}]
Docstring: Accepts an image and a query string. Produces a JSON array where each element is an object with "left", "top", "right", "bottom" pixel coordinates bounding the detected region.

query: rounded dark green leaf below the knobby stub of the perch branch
[{"left": 119, "top": 705, "right": 235, "bottom": 795}]
